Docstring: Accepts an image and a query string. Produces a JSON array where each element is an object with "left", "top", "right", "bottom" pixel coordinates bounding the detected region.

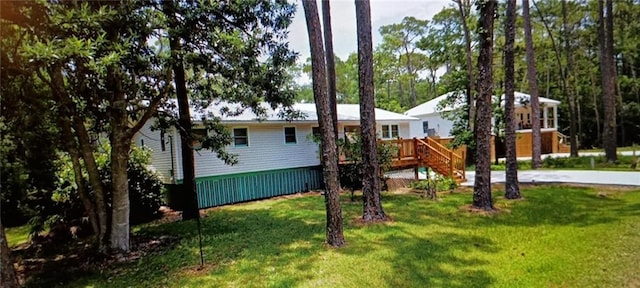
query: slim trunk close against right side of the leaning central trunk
[{"left": 322, "top": 0, "right": 338, "bottom": 139}]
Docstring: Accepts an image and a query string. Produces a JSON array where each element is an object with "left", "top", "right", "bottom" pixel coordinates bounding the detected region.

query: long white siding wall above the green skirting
[{"left": 176, "top": 123, "right": 320, "bottom": 179}]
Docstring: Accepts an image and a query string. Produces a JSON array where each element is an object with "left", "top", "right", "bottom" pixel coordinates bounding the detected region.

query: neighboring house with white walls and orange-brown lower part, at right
[{"left": 404, "top": 92, "right": 568, "bottom": 157}]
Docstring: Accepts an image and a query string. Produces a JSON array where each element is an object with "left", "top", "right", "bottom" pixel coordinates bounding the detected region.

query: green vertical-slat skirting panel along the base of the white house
[{"left": 190, "top": 166, "right": 323, "bottom": 208}]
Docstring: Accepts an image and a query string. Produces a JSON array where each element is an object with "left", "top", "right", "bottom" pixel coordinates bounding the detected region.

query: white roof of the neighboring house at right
[{"left": 404, "top": 92, "right": 560, "bottom": 116}]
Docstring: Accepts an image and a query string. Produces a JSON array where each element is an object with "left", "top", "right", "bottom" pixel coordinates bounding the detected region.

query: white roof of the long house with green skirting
[{"left": 172, "top": 102, "right": 418, "bottom": 122}]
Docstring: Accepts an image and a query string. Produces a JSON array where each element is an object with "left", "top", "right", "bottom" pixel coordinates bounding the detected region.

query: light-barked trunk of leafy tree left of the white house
[{"left": 107, "top": 68, "right": 131, "bottom": 253}]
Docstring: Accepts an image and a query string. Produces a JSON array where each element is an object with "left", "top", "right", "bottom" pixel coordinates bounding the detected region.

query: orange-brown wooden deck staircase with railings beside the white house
[{"left": 382, "top": 137, "right": 466, "bottom": 183}]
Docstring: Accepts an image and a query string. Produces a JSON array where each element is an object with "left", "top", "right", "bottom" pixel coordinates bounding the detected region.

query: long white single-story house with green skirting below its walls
[{"left": 134, "top": 104, "right": 417, "bottom": 208}]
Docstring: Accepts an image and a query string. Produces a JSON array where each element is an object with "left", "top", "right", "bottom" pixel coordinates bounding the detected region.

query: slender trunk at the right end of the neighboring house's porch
[{"left": 562, "top": 0, "right": 582, "bottom": 157}]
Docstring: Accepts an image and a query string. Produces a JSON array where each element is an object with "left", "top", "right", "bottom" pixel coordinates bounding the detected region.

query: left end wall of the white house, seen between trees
[{"left": 133, "top": 120, "right": 180, "bottom": 183}]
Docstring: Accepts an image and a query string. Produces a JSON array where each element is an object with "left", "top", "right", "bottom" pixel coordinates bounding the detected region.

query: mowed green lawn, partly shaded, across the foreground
[{"left": 45, "top": 186, "right": 640, "bottom": 287}]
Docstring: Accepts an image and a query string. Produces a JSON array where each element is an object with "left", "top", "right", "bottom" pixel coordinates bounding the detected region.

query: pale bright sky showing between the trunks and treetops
[{"left": 289, "top": 0, "right": 453, "bottom": 63}]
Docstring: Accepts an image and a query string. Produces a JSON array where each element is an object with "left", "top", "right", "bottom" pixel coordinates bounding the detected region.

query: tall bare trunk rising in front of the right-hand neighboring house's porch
[{"left": 522, "top": 0, "right": 542, "bottom": 169}]
